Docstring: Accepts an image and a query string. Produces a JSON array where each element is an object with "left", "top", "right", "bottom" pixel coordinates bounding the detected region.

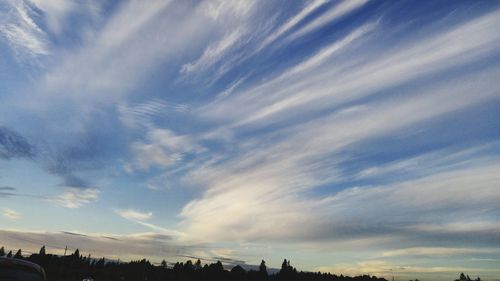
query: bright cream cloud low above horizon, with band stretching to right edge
[{"left": 181, "top": 144, "right": 500, "bottom": 245}]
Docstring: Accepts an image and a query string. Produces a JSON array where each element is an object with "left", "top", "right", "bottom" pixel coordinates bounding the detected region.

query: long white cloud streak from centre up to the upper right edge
[{"left": 200, "top": 7, "right": 500, "bottom": 128}]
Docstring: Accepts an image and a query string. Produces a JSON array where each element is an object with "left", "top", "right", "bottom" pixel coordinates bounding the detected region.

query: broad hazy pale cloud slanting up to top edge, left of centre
[{"left": 34, "top": 1, "right": 214, "bottom": 101}]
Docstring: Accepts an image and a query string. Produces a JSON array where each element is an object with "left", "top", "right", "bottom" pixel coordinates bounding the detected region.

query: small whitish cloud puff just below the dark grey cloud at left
[{"left": 53, "top": 187, "right": 100, "bottom": 209}]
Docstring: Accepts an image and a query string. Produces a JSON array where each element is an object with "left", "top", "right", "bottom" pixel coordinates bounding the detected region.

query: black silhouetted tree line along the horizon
[{"left": 0, "top": 246, "right": 481, "bottom": 281}]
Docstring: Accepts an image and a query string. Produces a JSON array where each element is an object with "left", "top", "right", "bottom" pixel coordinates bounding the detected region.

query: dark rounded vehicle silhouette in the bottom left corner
[{"left": 0, "top": 257, "right": 46, "bottom": 281}]
